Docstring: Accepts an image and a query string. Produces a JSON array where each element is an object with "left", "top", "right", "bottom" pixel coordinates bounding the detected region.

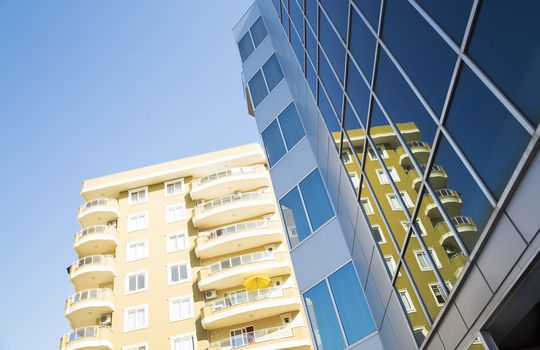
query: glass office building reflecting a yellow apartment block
[{"left": 234, "top": 0, "right": 540, "bottom": 349}]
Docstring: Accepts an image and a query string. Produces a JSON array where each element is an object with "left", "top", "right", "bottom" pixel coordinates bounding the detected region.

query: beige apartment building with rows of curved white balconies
[{"left": 60, "top": 144, "right": 312, "bottom": 350}]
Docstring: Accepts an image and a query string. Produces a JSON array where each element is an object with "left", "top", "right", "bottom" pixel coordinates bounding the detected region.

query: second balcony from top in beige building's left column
[{"left": 73, "top": 225, "right": 118, "bottom": 256}]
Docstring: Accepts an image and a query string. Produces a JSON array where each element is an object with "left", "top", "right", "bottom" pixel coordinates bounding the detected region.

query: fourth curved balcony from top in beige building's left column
[{"left": 65, "top": 288, "right": 114, "bottom": 328}]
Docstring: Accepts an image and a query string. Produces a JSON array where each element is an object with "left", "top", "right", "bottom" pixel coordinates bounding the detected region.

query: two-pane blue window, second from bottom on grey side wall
[{"left": 279, "top": 169, "right": 334, "bottom": 247}]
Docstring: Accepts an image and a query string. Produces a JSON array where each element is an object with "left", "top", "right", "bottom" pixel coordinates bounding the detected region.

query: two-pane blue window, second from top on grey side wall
[{"left": 248, "top": 54, "right": 283, "bottom": 108}]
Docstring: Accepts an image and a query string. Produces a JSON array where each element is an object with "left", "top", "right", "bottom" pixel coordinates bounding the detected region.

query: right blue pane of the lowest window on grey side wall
[{"left": 328, "top": 263, "right": 375, "bottom": 344}]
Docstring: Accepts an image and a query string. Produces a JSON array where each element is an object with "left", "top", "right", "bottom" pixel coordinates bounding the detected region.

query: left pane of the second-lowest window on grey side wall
[{"left": 279, "top": 187, "right": 311, "bottom": 247}]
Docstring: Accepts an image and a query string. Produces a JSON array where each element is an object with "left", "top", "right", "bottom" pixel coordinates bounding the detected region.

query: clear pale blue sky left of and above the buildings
[{"left": 0, "top": 0, "right": 258, "bottom": 350}]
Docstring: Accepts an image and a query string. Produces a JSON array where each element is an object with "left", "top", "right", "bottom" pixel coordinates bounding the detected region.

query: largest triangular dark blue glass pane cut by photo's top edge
[{"left": 417, "top": 0, "right": 473, "bottom": 46}]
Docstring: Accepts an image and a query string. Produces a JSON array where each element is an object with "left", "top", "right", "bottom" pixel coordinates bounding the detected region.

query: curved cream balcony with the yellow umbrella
[{"left": 201, "top": 287, "right": 300, "bottom": 330}]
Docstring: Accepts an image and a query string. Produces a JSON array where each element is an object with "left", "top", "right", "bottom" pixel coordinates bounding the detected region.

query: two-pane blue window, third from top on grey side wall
[{"left": 262, "top": 102, "right": 305, "bottom": 167}]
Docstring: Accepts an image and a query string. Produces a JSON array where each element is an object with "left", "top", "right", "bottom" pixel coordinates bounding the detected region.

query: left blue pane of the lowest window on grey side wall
[{"left": 304, "top": 281, "right": 345, "bottom": 350}]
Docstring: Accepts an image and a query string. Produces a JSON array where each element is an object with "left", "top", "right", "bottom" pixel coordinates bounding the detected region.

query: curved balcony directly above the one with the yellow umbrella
[{"left": 198, "top": 251, "right": 292, "bottom": 291}]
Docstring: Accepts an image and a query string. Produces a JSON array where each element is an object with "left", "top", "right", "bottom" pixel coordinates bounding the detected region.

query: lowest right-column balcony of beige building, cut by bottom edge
[{"left": 208, "top": 326, "right": 311, "bottom": 350}]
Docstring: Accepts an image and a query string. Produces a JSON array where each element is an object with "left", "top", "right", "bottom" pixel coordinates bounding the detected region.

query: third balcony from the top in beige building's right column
[{"left": 195, "top": 220, "right": 283, "bottom": 259}]
